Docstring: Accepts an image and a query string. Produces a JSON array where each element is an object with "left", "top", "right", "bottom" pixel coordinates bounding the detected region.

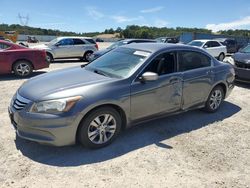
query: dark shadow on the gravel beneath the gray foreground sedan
[{"left": 15, "top": 102, "right": 241, "bottom": 167}]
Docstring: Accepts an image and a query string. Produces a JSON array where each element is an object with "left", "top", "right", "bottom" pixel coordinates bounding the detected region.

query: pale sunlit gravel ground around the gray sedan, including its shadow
[{"left": 0, "top": 49, "right": 250, "bottom": 188}]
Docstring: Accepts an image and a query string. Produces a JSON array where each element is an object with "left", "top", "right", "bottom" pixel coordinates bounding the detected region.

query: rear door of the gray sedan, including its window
[{"left": 177, "top": 51, "right": 214, "bottom": 110}]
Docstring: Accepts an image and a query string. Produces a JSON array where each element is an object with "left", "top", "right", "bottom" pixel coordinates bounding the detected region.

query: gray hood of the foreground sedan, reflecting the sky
[{"left": 18, "top": 66, "right": 115, "bottom": 101}]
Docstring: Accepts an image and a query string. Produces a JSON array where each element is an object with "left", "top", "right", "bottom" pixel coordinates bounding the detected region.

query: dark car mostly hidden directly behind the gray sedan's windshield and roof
[{"left": 90, "top": 39, "right": 157, "bottom": 61}]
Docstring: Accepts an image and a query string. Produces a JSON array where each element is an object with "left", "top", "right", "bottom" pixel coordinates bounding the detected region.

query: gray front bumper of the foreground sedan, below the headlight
[{"left": 8, "top": 106, "right": 79, "bottom": 146}]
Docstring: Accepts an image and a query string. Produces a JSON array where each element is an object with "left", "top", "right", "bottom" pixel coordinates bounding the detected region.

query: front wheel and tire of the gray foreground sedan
[{"left": 78, "top": 107, "right": 122, "bottom": 149}]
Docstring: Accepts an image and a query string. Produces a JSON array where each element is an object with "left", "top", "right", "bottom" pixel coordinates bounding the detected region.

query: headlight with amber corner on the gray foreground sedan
[{"left": 30, "top": 96, "right": 82, "bottom": 114}]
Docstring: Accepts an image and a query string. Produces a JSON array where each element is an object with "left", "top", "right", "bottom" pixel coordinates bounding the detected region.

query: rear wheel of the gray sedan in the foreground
[{"left": 204, "top": 86, "right": 225, "bottom": 113}]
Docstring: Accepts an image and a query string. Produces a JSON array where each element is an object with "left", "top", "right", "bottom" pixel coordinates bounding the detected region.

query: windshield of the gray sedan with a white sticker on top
[{"left": 86, "top": 48, "right": 150, "bottom": 78}]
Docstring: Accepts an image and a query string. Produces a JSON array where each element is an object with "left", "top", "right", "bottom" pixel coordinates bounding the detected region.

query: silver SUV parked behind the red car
[{"left": 32, "top": 37, "right": 98, "bottom": 62}]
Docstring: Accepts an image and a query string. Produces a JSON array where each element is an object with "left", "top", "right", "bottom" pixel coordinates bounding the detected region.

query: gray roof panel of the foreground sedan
[{"left": 121, "top": 43, "right": 197, "bottom": 53}]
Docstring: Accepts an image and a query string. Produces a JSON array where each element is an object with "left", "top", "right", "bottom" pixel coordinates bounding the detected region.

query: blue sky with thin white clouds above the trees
[{"left": 0, "top": 0, "right": 250, "bottom": 32}]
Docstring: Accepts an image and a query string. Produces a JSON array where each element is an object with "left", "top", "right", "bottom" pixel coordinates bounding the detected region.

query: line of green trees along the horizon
[{"left": 0, "top": 24, "right": 250, "bottom": 38}]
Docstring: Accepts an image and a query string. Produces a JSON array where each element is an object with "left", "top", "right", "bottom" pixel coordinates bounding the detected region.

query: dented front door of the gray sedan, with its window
[{"left": 131, "top": 52, "right": 182, "bottom": 120}]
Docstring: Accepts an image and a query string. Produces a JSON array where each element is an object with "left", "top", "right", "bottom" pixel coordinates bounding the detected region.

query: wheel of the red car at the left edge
[{"left": 13, "top": 60, "right": 33, "bottom": 77}]
